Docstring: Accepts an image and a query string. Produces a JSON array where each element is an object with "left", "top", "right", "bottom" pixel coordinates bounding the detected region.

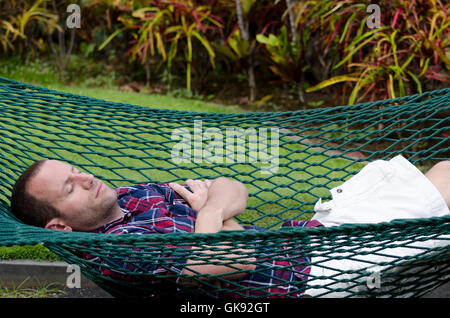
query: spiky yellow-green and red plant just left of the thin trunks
[{"left": 98, "top": 0, "right": 222, "bottom": 90}]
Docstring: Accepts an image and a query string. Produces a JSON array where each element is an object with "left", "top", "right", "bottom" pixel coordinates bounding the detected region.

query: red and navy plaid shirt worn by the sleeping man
[{"left": 89, "top": 184, "right": 322, "bottom": 297}]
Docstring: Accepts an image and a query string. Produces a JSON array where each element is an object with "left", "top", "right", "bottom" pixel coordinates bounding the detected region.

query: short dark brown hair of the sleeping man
[{"left": 11, "top": 159, "right": 61, "bottom": 227}]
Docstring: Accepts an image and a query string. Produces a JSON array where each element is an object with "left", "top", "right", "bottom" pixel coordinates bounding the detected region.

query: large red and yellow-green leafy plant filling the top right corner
[{"left": 307, "top": 0, "right": 450, "bottom": 104}]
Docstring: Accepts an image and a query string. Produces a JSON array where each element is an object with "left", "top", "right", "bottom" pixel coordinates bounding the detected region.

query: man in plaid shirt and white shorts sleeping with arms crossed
[{"left": 11, "top": 156, "right": 450, "bottom": 297}]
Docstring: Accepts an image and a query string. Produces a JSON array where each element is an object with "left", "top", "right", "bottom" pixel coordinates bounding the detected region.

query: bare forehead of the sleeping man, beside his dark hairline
[{"left": 28, "top": 160, "right": 71, "bottom": 201}]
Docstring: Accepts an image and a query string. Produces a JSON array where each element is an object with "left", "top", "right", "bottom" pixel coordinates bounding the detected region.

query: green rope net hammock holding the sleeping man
[{"left": 0, "top": 78, "right": 450, "bottom": 297}]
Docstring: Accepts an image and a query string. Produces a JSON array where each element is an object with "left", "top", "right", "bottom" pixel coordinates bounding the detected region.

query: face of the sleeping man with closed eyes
[{"left": 27, "top": 160, "right": 117, "bottom": 231}]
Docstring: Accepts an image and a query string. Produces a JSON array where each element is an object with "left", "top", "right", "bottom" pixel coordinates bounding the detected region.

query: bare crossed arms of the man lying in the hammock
[{"left": 169, "top": 177, "right": 255, "bottom": 279}]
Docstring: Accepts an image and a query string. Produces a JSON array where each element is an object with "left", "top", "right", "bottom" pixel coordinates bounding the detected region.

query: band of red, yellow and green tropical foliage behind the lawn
[{"left": 0, "top": 0, "right": 450, "bottom": 104}]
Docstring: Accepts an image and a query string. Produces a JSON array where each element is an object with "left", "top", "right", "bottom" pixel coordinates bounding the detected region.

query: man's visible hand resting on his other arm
[{"left": 169, "top": 179, "right": 212, "bottom": 212}]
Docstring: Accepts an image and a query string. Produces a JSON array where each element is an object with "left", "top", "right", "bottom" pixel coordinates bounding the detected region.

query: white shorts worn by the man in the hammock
[{"left": 305, "top": 156, "right": 450, "bottom": 297}]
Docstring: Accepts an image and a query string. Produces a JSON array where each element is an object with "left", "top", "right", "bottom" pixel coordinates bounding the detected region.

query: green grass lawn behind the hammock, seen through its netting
[{"left": 0, "top": 58, "right": 361, "bottom": 260}]
